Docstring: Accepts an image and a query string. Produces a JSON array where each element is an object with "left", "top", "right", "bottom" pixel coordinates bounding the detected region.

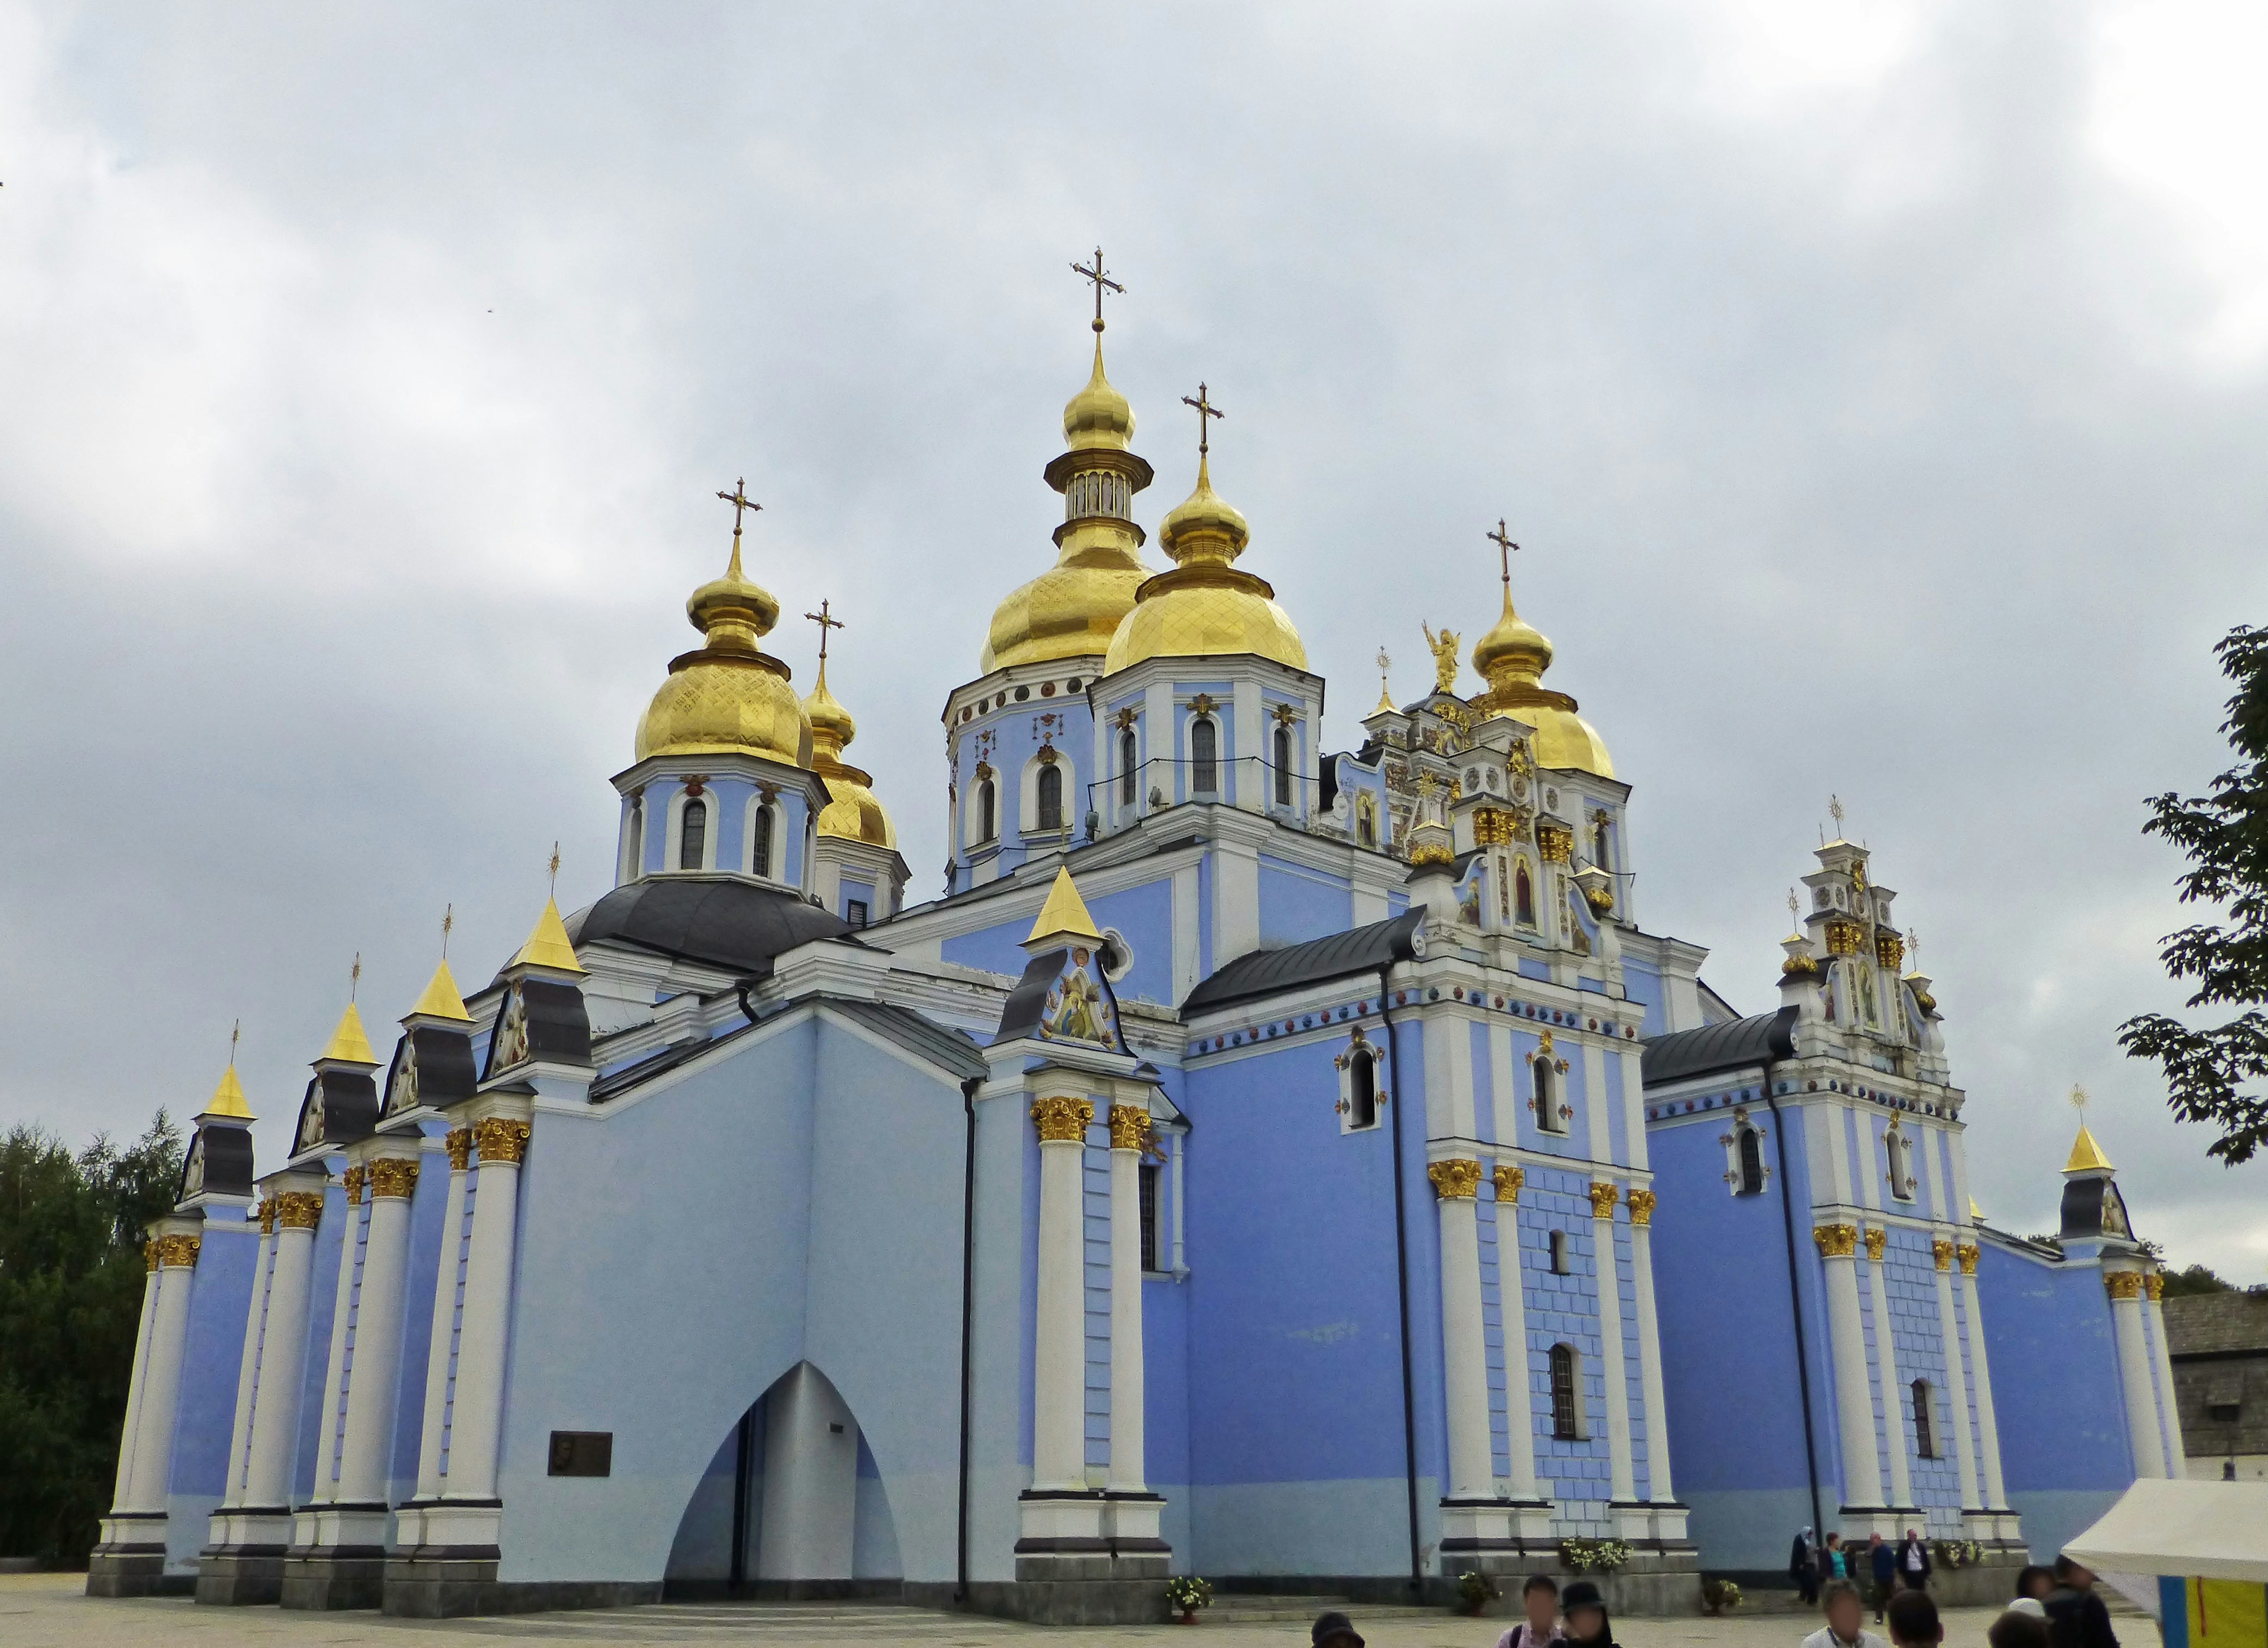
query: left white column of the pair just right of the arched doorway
[{"left": 1032, "top": 1097, "right": 1096, "bottom": 1494}]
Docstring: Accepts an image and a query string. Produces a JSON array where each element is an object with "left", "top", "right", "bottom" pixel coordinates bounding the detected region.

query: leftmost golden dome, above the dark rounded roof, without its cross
[{"left": 635, "top": 528, "right": 812, "bottom": 766}]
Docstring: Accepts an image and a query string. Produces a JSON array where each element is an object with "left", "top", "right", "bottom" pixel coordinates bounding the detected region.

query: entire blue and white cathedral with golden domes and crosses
[{"left": 89, "top": 274, "right": 2184, "bottom": 1623}]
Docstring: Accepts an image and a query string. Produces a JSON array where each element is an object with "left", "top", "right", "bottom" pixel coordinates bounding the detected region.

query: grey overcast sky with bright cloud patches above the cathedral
[{"left": 0, "top": 0, "right": 2268, "bottom": 1281}]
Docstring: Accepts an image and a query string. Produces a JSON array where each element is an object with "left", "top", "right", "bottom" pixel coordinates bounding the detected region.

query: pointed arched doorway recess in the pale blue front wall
[{"left": 662, "top": 1362, "right": 905, "bottom": 1600}]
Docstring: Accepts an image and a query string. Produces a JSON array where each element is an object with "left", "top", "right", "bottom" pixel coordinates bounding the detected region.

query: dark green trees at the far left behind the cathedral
[{"left": 0, "top": 1111, "right": 181, "bottom": 1567}]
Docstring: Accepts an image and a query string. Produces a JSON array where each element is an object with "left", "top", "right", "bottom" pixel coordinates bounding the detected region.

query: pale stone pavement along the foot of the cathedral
[{"left": 0, "top": 1573, "right": 2159, "bottom": 1648}]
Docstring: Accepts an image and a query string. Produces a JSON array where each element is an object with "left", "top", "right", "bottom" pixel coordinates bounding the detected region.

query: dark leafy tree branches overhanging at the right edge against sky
[{"left": 2119, "top": 624, "right": 2268, "bottom": 1165}]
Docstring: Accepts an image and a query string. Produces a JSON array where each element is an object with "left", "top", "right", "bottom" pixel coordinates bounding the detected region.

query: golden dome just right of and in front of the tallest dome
[{"left": 1102, "top": 456, "right": 1306, "bottom": 675}]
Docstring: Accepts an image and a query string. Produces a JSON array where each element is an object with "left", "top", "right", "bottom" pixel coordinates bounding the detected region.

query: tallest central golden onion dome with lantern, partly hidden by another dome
[{"left": 977, "top": 322, "right": 1150, "bottom": 675}]
